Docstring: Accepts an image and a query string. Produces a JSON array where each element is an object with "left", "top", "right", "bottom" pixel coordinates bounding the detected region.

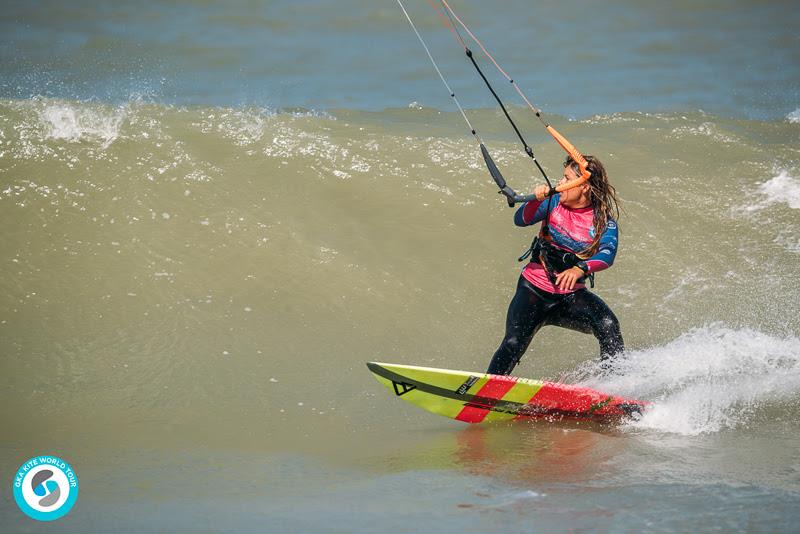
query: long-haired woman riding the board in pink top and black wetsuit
[{"left": 487, "top": 156, "right": 624, "bottom": 375}]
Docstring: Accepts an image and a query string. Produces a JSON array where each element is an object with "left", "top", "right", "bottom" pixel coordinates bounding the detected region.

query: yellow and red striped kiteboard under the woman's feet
[{"left": 367, "top": 362, "right": 647, "bottom": 423}]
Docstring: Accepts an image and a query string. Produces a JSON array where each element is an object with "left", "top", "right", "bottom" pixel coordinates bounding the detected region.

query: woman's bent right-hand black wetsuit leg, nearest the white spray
[{"left": 544, "top": 288, "right": 625, "bottom": 360}]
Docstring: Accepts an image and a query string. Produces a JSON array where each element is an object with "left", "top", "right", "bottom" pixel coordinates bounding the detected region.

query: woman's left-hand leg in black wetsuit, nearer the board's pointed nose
[{"left": 486, "top": 276, "right": 560, "bottom": 375}]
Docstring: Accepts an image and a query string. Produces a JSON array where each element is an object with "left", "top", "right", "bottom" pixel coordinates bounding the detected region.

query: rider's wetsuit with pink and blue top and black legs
[{"left": 487, "top": 195, "right": 624, "bottom": 375}]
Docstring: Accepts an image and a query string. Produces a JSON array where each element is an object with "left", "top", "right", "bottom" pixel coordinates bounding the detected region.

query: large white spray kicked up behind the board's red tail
[{"left": 585, "top": 324, "right": 800, "bottom": 435}]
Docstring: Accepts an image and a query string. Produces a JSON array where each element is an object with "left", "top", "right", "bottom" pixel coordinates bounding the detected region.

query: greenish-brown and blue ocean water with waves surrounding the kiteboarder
[{"left": 0, "top": 1, "right": 800, "bottom": 532}]
